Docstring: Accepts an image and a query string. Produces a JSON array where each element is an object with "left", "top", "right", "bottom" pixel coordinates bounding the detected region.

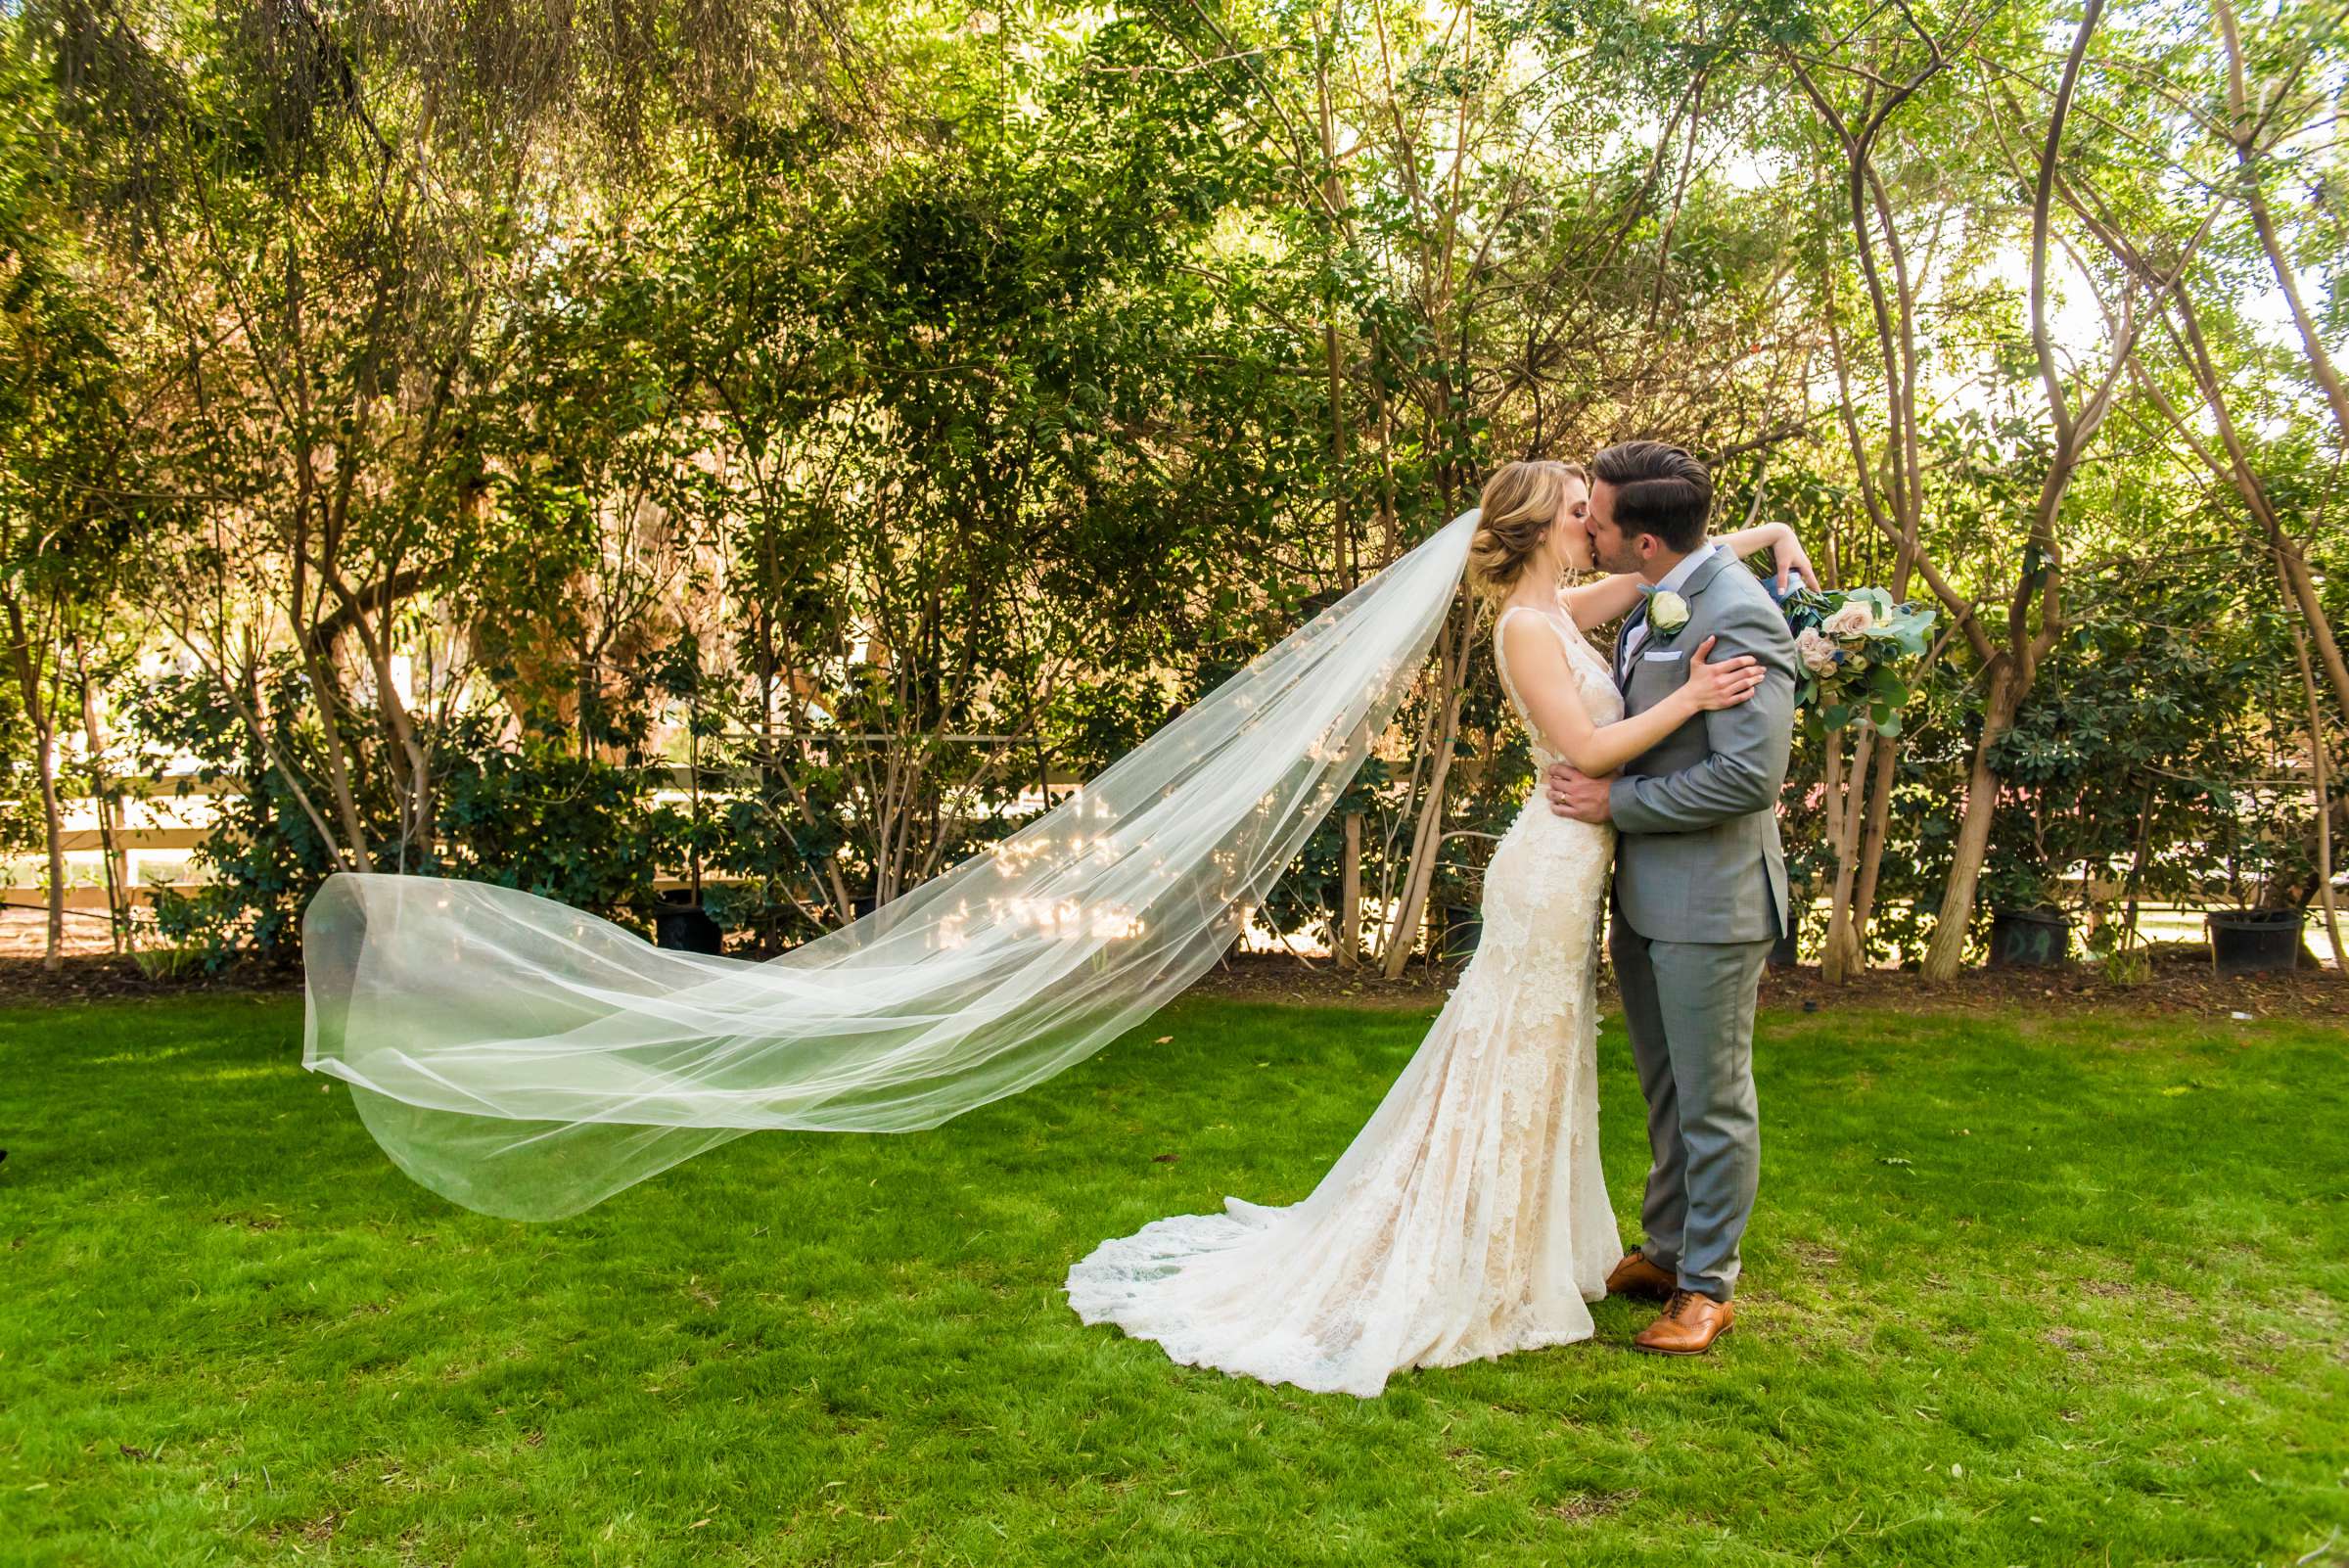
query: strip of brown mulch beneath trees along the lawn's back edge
[{"left": 0, "top": 950, "right": 2349, "bottom": 1024}]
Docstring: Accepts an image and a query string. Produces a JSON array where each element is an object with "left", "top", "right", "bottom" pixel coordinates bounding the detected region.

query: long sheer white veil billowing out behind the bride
[{"left": 303, "top": 512, "right": 1478, "bottom": 1219}]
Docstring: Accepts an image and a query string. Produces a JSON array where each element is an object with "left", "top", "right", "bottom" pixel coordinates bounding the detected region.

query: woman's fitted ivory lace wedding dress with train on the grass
[{"left": 1067, "top": 606, "right": 1623, "bottom": 1397}]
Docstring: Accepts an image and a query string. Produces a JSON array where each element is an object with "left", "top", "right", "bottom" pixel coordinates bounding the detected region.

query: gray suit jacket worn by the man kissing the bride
[{"left": 1609, "top": 549, "right": 1795, "bottom": 942}]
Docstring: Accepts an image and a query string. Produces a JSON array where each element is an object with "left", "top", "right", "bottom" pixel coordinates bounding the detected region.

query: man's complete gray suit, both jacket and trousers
[{"left": 1609, "top": 549, "right": 1795, "bottom": 1301}]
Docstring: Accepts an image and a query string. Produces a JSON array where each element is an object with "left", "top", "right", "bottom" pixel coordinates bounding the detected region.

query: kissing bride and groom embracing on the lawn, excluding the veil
[{"left": 1067, "top": 441, "right": 1819, "bottom": 1397}]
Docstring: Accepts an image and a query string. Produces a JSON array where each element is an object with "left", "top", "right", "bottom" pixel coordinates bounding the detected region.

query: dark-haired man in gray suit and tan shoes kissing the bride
[{"left": 1548, "top": 441, "right": 1795, "bottom": 1357}]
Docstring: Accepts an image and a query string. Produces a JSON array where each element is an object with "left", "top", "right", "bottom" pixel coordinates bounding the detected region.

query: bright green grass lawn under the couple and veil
[{"left": 0, "top": 997, "right": 2349, "bottom": 1568}]
